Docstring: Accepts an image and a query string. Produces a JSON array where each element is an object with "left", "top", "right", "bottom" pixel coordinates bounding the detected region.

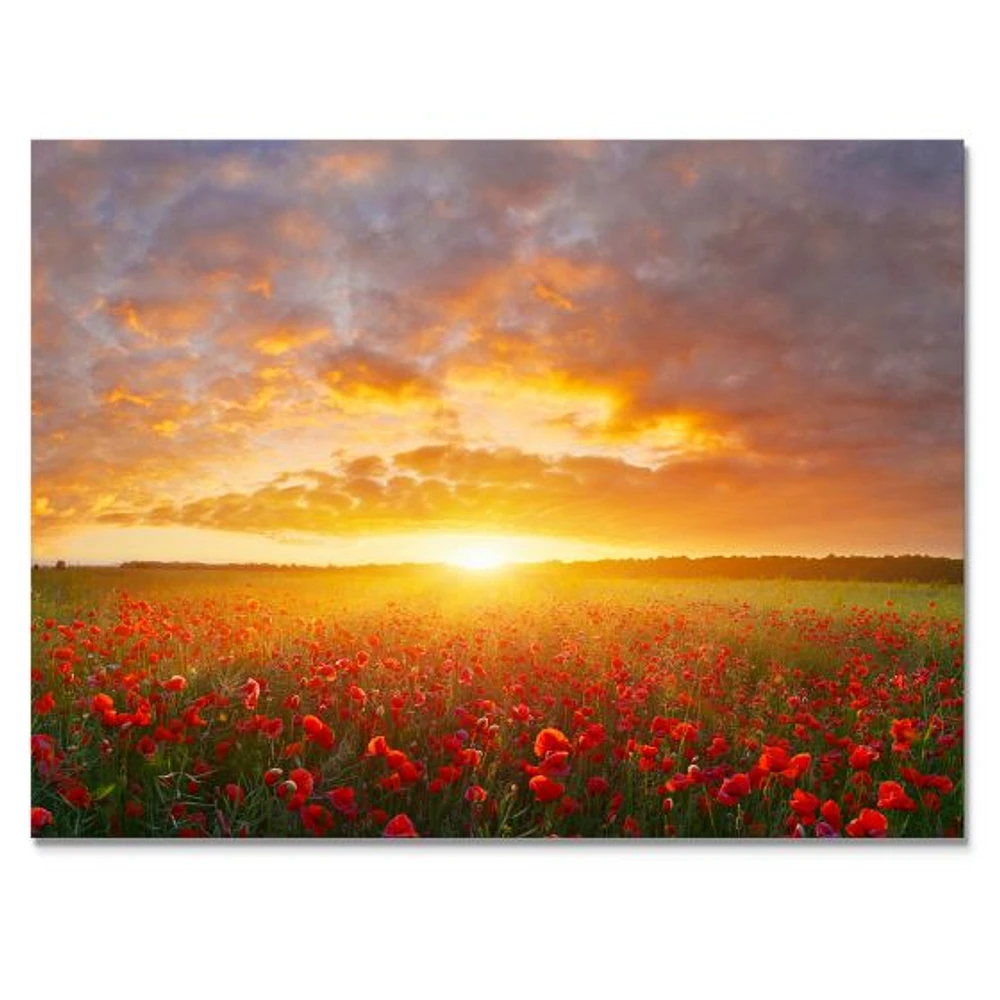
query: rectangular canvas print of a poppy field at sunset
[{"left": 31, "top": 139, "right": 965, "bottom": 832}]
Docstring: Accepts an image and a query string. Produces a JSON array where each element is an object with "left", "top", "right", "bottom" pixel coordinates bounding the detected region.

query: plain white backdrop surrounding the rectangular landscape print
[{"left": 0, "top": 0, "right": 1000, "bottom": 1000}]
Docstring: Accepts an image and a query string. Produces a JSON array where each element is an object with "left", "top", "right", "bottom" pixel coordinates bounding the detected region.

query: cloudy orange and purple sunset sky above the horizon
[{"left": 32, "top": 142, "right": 964, "bottom": 563}]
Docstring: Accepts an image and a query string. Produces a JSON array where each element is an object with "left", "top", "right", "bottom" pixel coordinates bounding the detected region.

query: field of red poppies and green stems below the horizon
[{"left": 31, "top": 566, "right": 964, "bottom": 839}]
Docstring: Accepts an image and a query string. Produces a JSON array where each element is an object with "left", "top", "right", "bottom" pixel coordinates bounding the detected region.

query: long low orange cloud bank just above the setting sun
[{"left": 86, "top": 446, "right": 961, "bottom": 552}]
